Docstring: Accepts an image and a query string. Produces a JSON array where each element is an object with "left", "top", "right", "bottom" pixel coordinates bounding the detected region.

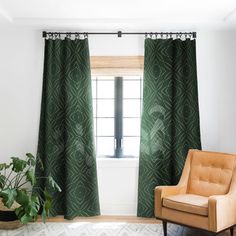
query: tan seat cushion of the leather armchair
[{"left": 162, "top": 194, "right": 208, "bottom": 216}]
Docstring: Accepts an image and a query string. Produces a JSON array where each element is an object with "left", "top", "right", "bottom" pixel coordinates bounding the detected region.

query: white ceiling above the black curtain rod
[{"left": 0, "top": 0, "right": 236, "bottom": 31}]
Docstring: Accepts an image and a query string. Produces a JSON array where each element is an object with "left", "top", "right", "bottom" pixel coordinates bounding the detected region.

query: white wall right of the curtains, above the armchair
[{"left": 197, "top": 32, "right": 236, "bottom": 153}]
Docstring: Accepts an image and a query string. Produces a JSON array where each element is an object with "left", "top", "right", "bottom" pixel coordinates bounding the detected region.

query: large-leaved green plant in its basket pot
[{"left": 0, "top": 153, "right": 61, "bottom": 229}]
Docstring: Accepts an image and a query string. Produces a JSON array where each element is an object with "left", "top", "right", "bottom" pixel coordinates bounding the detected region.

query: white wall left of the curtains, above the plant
[{"left": 0, "top": 29, "right": 44, "bottom": 161}]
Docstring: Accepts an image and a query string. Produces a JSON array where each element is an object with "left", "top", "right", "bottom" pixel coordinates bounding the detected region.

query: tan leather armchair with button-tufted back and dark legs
[{"left": 155, "top": 150, "right": 236, "bottom": 236}]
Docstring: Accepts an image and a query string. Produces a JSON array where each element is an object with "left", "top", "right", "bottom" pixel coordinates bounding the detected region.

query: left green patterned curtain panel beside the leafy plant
[{"left": 36, "top": 38, "right": 100, "bottom": 219}]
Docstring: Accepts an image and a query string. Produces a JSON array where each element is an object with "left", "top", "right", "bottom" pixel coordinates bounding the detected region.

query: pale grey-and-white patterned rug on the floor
[{"left": 0, "top": 222, "right": 229, "bottom": 236}]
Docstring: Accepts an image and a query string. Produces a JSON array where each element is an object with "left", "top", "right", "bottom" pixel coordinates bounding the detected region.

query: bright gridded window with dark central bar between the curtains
[{"left": 92, "top": 76, "right": 142, "bottom": 158}]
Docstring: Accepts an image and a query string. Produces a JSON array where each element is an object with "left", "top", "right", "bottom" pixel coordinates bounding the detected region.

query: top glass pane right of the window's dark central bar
[{"left": 123, "top": 80, "right": 140, "bottom": 98}]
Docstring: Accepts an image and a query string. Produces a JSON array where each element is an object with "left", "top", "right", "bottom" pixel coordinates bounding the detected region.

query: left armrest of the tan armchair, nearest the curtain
[{"left": 155, "top": 185, "right": 186, "bottom": 217}]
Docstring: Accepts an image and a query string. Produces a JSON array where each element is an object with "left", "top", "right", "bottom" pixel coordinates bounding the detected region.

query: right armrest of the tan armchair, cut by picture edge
[{"left": 208, "top": 192, "right": 236, "bottom": 232}]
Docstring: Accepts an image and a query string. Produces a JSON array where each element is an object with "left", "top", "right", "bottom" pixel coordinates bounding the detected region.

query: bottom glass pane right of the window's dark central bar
[{"left": 123, "top": 137, "right": 140, "bottom": 157}]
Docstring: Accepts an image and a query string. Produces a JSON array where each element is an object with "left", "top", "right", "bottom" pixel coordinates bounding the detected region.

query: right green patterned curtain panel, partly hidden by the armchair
[{"left": 138, "top": 38, "right": 201, "bottom": 217}]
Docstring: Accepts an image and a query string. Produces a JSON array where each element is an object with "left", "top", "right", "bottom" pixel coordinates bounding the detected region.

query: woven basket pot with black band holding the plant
[{"left": 0, "top": 198, "right": 23, "bottom": 229}]
